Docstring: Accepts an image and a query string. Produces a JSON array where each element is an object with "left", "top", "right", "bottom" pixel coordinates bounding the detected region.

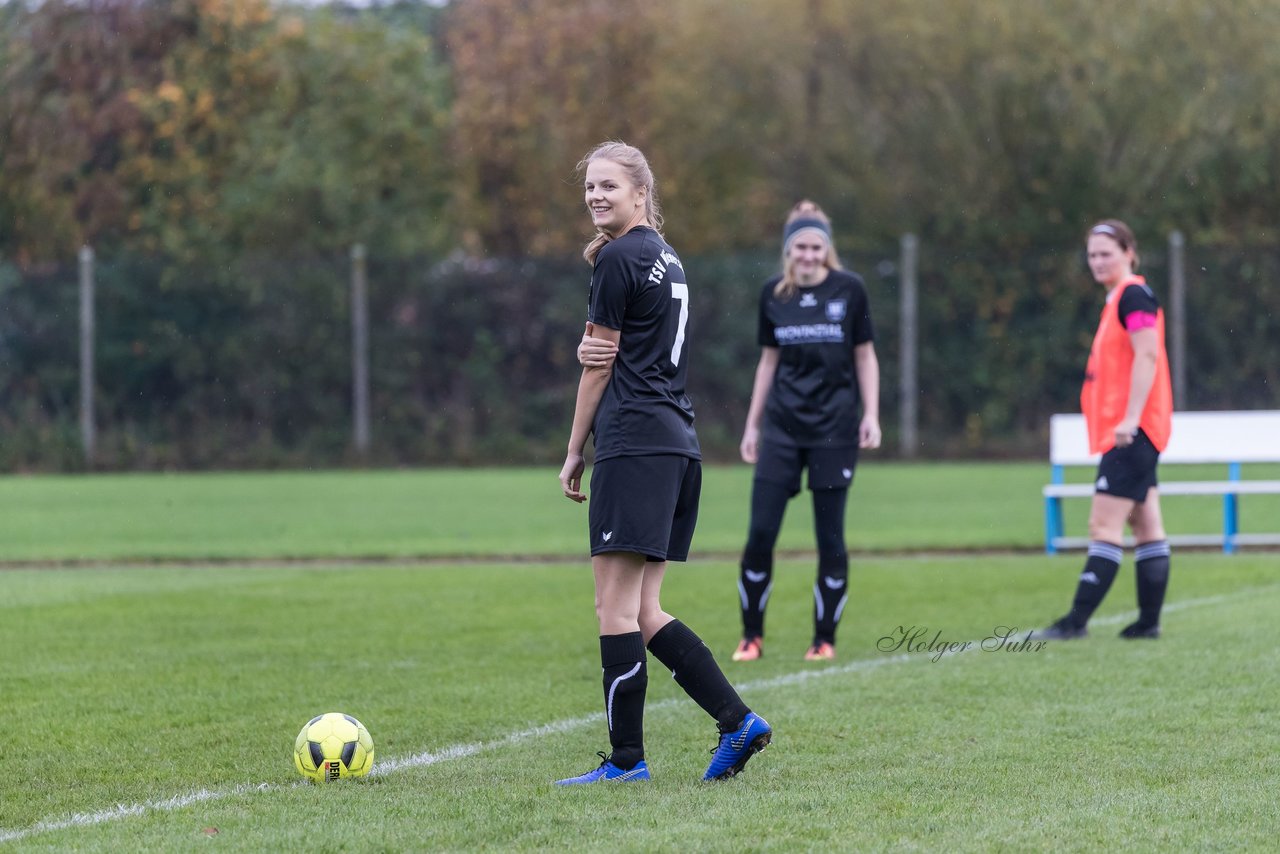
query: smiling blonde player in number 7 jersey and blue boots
[{"left": 557, "top": 142, "right": 773, "bottom": 786}]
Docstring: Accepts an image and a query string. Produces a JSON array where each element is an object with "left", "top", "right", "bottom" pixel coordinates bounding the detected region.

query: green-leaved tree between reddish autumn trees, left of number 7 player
[{"left": 221, "top": 10, "right": 454, "bottom": 256}]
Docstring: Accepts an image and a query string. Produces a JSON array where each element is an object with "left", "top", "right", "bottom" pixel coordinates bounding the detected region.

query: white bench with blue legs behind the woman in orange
[{"left": 1043, "top": 411, "right": 1280, "bottom": 554}]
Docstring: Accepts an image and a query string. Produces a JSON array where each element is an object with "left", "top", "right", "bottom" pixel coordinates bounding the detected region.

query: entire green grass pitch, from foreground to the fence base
[{"left": 0, "top": 465, "right": 1280, "bottom": 851}]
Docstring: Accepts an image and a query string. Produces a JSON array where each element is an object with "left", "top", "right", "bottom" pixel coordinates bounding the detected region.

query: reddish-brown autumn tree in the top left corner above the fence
[{"left": 0, "top": 0, "right": 179, "bottom": 259}]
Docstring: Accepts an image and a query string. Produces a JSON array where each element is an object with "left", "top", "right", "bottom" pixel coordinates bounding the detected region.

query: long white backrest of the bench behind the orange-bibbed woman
[{"left": 1048, "top": 410, "right": 1280, "bottom": 466}]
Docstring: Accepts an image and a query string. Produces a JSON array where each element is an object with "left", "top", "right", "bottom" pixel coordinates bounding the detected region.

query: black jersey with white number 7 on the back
[{"left": 586, "top": 225, "right": 701, "bottom": 461}]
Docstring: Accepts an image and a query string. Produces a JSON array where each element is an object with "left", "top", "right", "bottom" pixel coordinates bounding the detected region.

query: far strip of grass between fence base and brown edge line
[{"left": 0, "top": 460, "right": 1280, "bottom": 565}]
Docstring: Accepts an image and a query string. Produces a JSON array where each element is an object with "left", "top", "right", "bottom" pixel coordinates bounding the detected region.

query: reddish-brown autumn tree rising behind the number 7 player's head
[{"left": 445, "top": 0, "right": 667, "bottom": 256}]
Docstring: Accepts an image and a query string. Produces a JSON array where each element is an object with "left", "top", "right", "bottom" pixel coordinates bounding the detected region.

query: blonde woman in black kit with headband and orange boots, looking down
[{"left": 733, "top": 201, "right": 881, "bottom": 661}]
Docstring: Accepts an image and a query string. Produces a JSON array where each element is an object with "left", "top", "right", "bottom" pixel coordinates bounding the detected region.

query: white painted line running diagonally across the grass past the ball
[{"left": 0, "top": 585, "right": 1274, "bottom": 844}]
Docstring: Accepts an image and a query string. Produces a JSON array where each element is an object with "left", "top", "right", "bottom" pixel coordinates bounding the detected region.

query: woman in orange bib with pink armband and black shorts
[{"left": 1041, "top": 219, "right": 1174, "bottom": 640}]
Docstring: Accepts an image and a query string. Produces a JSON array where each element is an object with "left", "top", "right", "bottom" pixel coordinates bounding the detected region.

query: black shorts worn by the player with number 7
[{"left": 588, "top": 455, "right": 703, "bottom": 561}]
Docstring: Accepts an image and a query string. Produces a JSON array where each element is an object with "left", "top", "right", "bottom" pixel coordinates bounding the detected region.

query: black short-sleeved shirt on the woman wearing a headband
[{"left": 758, "top": 270, "right": 874, "bottom": 448}]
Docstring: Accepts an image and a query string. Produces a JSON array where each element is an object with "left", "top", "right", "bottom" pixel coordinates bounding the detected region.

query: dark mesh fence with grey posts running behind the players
[{"left": 0, "top": 242, "right": 1280, "bottom": 471}]
